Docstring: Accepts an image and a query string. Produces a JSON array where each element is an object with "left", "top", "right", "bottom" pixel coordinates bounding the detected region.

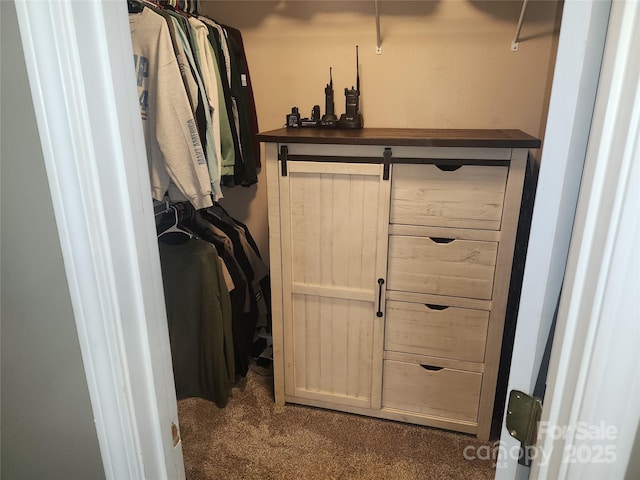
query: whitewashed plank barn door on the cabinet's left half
[{"left": 281, "top": 162, "right": 381, "bottom": 408}]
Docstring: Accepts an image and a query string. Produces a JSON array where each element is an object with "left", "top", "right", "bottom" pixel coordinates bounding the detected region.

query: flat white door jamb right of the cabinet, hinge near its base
[{"left": 495, "top": 0, "right": 611, "bottom": 480}]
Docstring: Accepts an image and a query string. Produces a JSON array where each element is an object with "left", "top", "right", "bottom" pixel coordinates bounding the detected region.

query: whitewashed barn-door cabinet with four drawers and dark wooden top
[{"left": 259, "top": 128, "right": 540, "bottom": 440}]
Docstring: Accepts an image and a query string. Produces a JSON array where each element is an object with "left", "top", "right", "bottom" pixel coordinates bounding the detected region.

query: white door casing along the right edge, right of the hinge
[{"left": 531, "top": 1, "right": 640, "bottom": 479}]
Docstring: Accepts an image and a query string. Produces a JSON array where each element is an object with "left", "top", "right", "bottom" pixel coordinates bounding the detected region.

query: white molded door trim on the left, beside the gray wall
[{"left": 16, "top": 0, "right": 185, "bottom": 480}]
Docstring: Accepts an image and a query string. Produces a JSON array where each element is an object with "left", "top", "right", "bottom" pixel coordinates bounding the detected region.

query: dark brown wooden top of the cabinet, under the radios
[{"left": 258, "top": 127, "right": 540, "bottom": 148}]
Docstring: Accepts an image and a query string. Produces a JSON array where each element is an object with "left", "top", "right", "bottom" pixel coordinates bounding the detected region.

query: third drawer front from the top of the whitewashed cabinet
[{"left": 384, "top": 300, "right": 489, "bottom": 362}]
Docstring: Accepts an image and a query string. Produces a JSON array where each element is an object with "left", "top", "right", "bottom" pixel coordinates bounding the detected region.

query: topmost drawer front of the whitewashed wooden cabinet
[{"left": 390, "top": 164, "right": 508, "bottom": 230}]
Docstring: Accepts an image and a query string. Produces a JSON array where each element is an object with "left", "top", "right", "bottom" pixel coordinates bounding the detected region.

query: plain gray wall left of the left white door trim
[{"left": 0, "top": 1, "right": 104, "bottom": 480}]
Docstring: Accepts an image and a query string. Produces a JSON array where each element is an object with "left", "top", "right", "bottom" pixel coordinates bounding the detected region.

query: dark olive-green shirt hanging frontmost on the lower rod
[{"left": 158, "top": 238, "right": 236, "bottom": 407}]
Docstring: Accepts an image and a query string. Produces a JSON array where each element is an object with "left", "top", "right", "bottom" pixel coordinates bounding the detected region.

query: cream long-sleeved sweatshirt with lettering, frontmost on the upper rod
[{"left": 129, "top": 8, "right": 212, "bottom": 209}]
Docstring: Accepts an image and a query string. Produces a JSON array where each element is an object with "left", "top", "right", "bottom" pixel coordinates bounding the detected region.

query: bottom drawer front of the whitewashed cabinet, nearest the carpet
[{"left": 382, "top": 360, "right": 482, "bottom": 422}]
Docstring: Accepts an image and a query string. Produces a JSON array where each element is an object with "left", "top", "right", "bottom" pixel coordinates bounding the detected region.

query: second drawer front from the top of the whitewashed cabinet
[{"left": 387, "top": 235, "right": 498, "bottom": 300}]
